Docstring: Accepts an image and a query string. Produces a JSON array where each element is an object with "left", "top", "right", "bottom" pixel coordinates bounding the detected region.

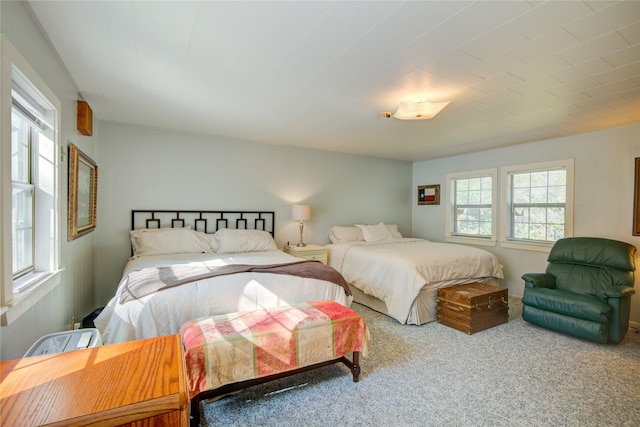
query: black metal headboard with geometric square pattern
[{"left": 131, "top": 209, "right": 276, "bottom": 236}]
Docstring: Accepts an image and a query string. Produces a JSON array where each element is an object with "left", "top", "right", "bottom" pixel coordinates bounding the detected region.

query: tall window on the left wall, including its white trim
[{"left": 0, "top": 35, "right": 61, "bottom": 325}]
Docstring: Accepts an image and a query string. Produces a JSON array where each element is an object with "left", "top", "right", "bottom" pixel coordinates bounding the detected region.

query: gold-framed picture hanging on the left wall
[{"left": 68, "top": 144, "right": 98, "bottom": 241}]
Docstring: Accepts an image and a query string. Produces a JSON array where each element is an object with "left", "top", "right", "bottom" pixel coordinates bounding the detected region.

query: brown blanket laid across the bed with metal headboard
[{"left": 120, "top": 260, "right": 351, "bottom": 304}]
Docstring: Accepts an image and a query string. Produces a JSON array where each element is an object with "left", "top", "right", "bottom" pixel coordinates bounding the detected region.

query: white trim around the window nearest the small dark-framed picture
[{"left": 445, "top": 168, "right": 498, "bottom": 246}]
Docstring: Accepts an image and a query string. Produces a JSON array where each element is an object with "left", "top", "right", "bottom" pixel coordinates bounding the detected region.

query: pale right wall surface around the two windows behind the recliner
[{"left": 412, "top": 125, "right": 640, "bottom": 323}]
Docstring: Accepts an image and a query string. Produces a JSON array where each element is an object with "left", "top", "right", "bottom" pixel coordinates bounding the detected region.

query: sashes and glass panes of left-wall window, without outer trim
[{"left": 11, "top": 72, "right": 58, "bottom": 292}]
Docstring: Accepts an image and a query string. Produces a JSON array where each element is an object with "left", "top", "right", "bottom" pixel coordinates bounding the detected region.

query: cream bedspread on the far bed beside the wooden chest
[{"left": 327, "top": 238, "right": 504, "bottom": 324}]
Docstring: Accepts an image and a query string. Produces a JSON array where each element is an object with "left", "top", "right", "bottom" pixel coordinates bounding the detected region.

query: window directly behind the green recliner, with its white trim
[{"left": 502, "top": 159, "right": 573, "bottom": 250}]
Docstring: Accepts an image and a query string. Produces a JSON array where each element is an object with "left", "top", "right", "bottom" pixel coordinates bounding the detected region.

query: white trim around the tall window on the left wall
[{"left": 0, "top": 33, "right": 63, "bottom": 326}]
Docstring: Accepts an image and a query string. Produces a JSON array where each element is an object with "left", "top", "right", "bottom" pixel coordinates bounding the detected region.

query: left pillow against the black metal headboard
[{"left": 131, "top": 228, "right": 212, "bottom": 256}]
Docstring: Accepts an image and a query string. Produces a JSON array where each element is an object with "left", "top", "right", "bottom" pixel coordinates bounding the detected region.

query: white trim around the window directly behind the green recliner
[{"left": 500, "top": 159, "right": 575, "bottom": 253}]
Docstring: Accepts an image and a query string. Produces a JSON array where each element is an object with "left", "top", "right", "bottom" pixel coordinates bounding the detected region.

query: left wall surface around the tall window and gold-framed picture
[{"left": 0, "top": 1, "right": 95, "bottom": 360}]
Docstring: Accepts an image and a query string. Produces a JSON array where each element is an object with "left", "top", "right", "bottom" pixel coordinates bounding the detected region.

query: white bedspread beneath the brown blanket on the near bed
[{"left": 94, "top": 251, "right": 351, "bottom": 344}]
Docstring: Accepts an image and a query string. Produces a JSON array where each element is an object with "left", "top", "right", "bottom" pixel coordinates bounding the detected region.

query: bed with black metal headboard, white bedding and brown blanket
[{"left": 94, "top": 210, "right": 352, "bottom": 344}]
